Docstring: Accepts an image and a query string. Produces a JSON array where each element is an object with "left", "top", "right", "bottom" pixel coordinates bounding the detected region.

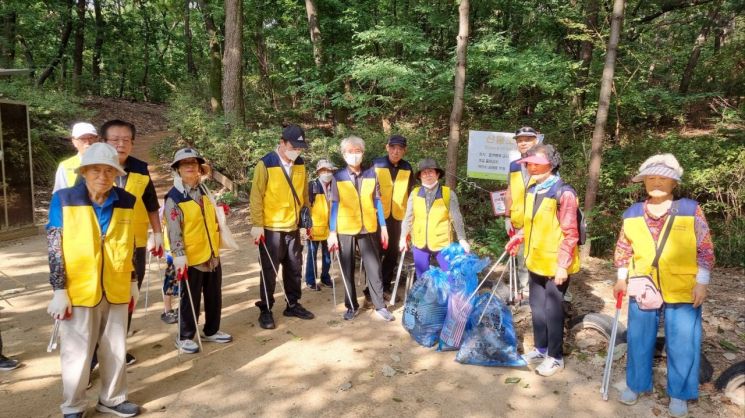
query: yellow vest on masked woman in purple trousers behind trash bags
[{"left": 411, "top": 186, "right": 452, "bottom": 251}]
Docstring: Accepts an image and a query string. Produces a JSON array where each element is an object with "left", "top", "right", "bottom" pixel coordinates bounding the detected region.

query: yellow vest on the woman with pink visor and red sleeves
[{"left": 523, "top": 180, "right": 580, "bottom": 277}]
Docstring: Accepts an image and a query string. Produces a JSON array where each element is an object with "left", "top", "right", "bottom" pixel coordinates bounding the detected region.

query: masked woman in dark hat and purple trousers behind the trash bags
[{"left": 398, "top": 158, "right": 471, "bottom": 278}]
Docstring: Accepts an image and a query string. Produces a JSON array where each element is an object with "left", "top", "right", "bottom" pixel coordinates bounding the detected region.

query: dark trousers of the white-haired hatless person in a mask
[{"left": 339, "top": 234, "right": 385, "bottom": 310}]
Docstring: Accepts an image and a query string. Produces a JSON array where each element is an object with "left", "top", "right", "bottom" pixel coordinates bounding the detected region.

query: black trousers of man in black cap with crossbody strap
[{"left": 256, "top": 229, "right": 303, "bottom": 311}]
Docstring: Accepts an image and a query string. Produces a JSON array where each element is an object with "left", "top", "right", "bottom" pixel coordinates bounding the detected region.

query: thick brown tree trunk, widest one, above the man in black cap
[{"left": 222, "top": 0, "right": 244, "bottom": 124}]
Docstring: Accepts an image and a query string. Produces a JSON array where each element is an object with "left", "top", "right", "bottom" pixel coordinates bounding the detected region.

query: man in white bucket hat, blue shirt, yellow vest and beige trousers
[{"left": 47, "top": 143, "right": 139, "bottom": 417}]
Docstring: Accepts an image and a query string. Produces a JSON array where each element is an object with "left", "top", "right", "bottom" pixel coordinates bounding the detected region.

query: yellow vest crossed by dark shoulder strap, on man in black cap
[{"left": 261, "top": 151, "right": 307, "bottom": 229}]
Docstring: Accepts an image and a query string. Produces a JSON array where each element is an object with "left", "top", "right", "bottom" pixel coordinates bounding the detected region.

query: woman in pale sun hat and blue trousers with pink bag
[{"left": 614, "top": 154, "right": 714, "bottom": 417}]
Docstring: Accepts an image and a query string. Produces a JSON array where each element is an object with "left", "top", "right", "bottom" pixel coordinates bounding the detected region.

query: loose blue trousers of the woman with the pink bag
[{"left": 626, "top": 298, "right": 701, "bottom": 400}]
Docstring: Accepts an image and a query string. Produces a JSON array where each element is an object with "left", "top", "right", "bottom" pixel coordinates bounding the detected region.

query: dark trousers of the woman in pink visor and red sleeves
[{"left": 530, "top": 271, "right": 569, "bottom": 359}]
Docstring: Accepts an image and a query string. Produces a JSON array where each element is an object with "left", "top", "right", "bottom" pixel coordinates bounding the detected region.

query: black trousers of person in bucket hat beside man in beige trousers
[{"left": 179, "top": 265, "right": 222, "bottom": 340}]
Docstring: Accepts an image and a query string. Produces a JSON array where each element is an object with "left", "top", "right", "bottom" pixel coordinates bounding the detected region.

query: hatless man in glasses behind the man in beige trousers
[{"left": 101, "top": 119, "right": 163, "bottom": 365}]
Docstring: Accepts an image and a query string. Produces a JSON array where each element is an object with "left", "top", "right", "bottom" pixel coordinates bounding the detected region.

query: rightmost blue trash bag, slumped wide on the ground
[{"left": 455, "top": 293, "right": 527, "bottom": 367}]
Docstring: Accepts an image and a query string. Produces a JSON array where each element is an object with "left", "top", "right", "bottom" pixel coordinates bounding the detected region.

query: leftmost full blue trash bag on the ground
[{"left": 401, "top": 267, "right": 449, "bottom": 347}]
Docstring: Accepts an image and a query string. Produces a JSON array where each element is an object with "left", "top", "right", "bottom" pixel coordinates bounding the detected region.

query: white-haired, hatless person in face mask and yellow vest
[{"left": 326, "top": 136, "right": 395, "bottom": 321}]
